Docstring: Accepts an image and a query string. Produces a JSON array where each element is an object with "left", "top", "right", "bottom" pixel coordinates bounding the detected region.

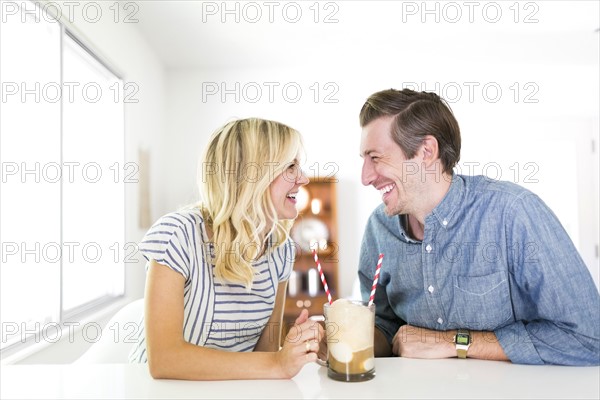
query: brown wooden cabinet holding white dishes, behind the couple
[{"left": 284, "top": 177, "right": 339, "bottom": 333}]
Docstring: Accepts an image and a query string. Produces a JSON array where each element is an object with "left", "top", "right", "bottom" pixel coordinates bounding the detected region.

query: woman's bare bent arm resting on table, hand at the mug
[{"left": 145, "top": 260, "right": 317, "bottom": 380}]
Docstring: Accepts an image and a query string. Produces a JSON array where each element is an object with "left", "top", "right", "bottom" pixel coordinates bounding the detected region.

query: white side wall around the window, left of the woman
[{"left": 13, "top": 2, "right": 168, "bottom": 364}]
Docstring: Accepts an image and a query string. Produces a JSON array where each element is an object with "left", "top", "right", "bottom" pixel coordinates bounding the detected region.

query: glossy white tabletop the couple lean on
[{"left": 0, "top": 358, "right": 600, "bottom": 399}]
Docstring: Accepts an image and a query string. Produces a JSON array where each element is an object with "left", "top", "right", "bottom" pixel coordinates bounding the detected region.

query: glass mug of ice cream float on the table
[{"left": 322, "top": 299, "right": 375, "bottom": 382}]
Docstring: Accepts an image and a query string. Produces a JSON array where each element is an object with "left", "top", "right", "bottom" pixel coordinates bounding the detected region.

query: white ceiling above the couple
[{"left": 136, "top": 0, "right": 600, "bottom": 68}]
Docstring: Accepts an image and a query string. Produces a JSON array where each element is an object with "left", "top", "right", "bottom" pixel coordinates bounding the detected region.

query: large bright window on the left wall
[{"left": 0, "top": 1, "right": 125, "bottom": 350}]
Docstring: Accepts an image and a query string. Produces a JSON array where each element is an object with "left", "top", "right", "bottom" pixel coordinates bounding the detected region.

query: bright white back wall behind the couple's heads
[{"left": 163, "top": 57, "right": 598, "bottom": 296}]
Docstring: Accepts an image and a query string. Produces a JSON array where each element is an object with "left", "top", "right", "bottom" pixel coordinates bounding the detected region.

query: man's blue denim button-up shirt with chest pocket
[{"left": 359, "top": 175, "right": 600, "bottom": 365}]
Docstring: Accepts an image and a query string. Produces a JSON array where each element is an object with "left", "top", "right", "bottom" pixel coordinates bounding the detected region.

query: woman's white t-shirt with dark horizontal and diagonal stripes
[{"left": 129, "top": 209, "right": 295, "bottom": 362}]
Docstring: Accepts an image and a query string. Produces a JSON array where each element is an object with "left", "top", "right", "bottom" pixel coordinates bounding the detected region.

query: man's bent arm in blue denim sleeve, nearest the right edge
[{"left": 494, "top": 194, "right": 600, "bottom": 365}]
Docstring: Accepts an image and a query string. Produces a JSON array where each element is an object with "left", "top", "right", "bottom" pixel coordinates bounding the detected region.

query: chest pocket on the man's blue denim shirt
[{"left": 451, "top": 271, "right": 512, "bottom": 331}]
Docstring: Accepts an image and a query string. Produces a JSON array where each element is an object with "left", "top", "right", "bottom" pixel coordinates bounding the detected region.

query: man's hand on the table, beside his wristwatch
[{"left": 392, "top": 325, "right": 456, "bottom": 358}]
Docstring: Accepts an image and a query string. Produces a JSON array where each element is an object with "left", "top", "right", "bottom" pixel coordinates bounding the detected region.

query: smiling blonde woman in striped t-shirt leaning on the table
[{"left": 130, "top": 118, "right": 323, "bottom": 380}]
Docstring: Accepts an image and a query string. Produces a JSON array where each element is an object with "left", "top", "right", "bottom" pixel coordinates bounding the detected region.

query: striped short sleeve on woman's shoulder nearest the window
[{"left": 139, "top": 213, "right": 199, "bottom": 281}]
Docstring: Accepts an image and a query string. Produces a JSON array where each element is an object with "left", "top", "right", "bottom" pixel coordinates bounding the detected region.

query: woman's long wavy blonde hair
[{"left": 199, "top": 118, "right": 303, "bottom": 289}]
